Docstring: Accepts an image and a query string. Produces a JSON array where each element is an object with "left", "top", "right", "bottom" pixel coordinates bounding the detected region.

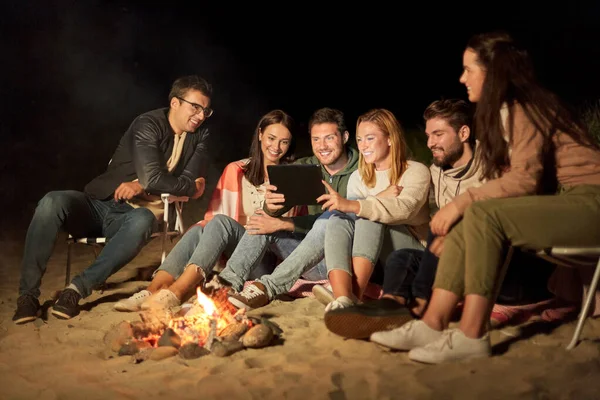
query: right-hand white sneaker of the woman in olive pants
[{"left": 408, "top": 329, "right": 492, "bottom": 364}]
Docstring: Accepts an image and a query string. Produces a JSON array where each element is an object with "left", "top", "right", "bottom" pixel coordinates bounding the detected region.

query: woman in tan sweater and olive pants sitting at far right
[{"left": 371, "top": 33, "right": 600, "bottom": 363}]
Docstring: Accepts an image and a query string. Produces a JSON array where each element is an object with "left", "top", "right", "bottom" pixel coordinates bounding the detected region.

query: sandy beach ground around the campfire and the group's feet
[{"left": 0, "top": 234, "right": 600, "bottom": 400}]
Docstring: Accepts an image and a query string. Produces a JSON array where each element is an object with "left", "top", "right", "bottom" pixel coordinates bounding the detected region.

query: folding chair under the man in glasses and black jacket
[{"left": 65, "top": 193, "right": 188, "bottom": 286}]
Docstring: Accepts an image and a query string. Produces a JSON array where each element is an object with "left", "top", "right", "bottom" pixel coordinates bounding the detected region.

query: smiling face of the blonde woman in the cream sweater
[{"left": 356, "top": 121, "right": 391, "bottom": 171}]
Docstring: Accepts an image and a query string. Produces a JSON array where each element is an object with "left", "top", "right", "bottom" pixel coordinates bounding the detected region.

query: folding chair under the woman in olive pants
[{"left": 537, "top": 247, "right": 600, "bottom": 350}]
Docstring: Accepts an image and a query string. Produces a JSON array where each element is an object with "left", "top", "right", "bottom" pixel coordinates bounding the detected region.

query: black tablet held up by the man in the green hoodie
[{"left": 267, "top": 164, "right": 327, "bottom": 206}]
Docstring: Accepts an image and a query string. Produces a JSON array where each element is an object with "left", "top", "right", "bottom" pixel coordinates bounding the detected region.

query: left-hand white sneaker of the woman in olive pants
[{"left": 370, "top": 319, "right": 442, "bottom": 350}]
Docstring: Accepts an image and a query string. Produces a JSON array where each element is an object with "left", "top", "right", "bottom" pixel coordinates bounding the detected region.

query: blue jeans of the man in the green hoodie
[{"left": 219, "top": 213, "right": 330, "bottom": 299}]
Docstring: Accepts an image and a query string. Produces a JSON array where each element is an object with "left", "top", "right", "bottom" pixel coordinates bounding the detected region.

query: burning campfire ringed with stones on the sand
[{"left": 104, "top": 288, "right": 282, "bottom": 363}]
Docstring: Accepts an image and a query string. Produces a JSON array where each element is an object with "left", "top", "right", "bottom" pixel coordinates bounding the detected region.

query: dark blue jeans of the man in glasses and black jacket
[{"left": 19, "top": 190, "right": 157, "bottom": 297}]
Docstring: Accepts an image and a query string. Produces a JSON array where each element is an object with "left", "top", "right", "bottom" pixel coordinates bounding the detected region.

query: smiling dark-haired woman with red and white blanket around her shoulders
[{"left": 114, "top": 110, "right": 299, "bottom": 311}]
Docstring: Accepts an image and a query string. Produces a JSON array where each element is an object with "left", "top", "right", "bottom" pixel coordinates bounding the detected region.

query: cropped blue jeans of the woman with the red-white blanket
[{"left": 155, "top": 214, "right": 274, "bottom": 279}]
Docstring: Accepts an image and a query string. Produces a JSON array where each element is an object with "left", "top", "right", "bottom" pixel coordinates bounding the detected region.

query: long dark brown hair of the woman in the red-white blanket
[{"left": 244, "top": 110, "right": 295, "bottom": 186}]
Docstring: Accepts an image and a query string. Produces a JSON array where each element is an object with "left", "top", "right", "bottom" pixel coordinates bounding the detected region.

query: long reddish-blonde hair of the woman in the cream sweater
[{"left": 356, "top": 108, "right": 408, "bottom": 188}]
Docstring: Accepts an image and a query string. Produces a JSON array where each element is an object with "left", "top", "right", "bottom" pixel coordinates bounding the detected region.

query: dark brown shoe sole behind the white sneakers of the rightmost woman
[{"left": 324, "top": 309, "right": 413, "bottom": 339}]
